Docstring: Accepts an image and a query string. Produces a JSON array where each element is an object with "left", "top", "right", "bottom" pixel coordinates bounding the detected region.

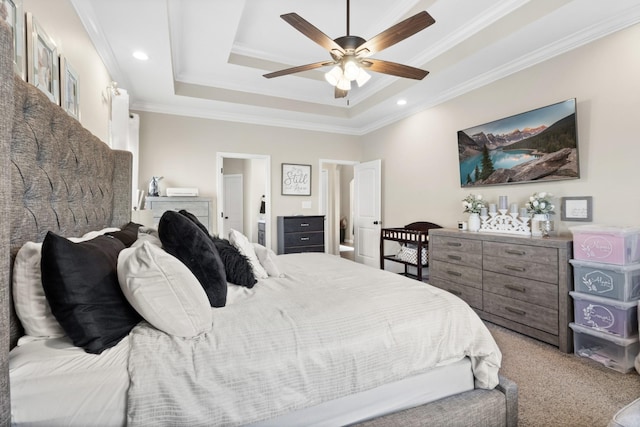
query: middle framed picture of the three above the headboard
[{"left": 27, "top": 12, "right": 60, "bottom": 105}]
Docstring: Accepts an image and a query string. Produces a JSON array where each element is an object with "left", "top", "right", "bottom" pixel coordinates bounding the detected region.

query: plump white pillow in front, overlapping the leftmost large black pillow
[{"left": 118, "top": 241, "right": 212, "bottom": 337}]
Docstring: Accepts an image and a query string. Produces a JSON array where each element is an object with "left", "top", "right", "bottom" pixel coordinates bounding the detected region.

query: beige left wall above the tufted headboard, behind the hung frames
[{"left": 22, "top": 0, "right": 111, "bottom": 142}]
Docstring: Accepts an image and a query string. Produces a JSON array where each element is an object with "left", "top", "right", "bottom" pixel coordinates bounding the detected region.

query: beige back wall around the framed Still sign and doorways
[{"left": 138, "top": 112, "right": 362, "bottom": 245}]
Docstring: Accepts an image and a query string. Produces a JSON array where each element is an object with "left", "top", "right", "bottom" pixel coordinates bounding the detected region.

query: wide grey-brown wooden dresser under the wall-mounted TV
[{"left": 429, "top": 229, "right": 573, "bottom": 353}]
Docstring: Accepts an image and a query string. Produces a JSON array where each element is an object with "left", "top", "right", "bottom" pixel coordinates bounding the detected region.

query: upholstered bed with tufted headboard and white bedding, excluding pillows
[{"left": 0, "top": 18, "right": 517, "bottom": 426}]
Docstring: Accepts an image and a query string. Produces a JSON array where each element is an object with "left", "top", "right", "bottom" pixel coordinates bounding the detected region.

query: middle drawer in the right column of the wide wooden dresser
[{"left": 482, "top": 271, "right": 558, "bottom": 310}]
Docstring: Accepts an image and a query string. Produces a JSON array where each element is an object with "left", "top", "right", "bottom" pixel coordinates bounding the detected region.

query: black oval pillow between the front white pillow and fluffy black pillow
[{"left": 158, "top": 211, "right": 227, "bottom": 307}]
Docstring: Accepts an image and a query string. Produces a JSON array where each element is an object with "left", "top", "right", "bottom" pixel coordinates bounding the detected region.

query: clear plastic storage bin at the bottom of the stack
[{"left": 569, "top": 322, "right": 640, "bottom": 374}]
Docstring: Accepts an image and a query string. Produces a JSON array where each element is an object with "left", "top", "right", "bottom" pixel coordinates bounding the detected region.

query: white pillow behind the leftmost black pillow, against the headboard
[{"left": 13, "top": 227, "right": 120, "bottom": 338}]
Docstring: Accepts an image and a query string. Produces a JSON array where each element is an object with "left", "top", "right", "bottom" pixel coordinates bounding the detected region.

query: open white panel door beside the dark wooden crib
[{"left": 353, "top": 160, "right": 382, "bottom": 268}]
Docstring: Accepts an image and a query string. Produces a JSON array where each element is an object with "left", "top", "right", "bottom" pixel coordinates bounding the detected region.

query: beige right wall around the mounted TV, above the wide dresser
[{"left": 362, "top": 21, "right": 640, "bottom": 237}]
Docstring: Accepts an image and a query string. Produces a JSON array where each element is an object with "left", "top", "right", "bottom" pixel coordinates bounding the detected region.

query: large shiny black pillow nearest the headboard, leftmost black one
[{"left": 41, "top": 232, "right": 141, "bottom": 354}]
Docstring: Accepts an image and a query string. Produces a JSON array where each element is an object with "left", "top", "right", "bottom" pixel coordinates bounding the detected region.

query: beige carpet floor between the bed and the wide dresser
[{"left": 487, "top": 323, "right": 640, "bottom": 427}]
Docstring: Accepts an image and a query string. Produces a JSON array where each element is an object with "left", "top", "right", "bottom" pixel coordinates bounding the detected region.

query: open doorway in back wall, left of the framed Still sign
[{"left": 216, "top": 152, "right": 271, "bottom": 247}]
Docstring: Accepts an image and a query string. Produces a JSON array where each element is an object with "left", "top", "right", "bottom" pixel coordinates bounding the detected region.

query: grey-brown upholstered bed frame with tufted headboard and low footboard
[{"left": 0, "top": 22, "right": 518, "bottom": 426}]
